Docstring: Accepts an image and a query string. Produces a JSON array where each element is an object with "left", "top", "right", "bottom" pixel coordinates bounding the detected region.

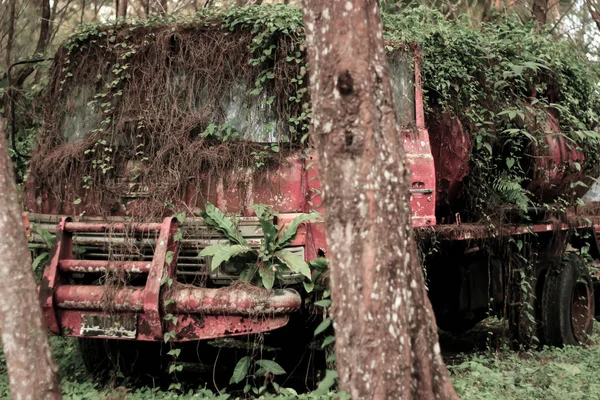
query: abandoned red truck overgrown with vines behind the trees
[{"left": 18, "top": 9, "right": 600, "bottom": 382}]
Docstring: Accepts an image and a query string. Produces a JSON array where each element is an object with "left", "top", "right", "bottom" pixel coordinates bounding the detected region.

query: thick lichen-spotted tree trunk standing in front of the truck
[{"left": 304, "top": 0, "right": 457, "bottom": 399}]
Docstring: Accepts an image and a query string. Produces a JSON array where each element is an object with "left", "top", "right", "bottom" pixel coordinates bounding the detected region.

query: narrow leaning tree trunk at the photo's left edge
[{"left": 0, "top": 118, "right": 61, "bottom": 399}]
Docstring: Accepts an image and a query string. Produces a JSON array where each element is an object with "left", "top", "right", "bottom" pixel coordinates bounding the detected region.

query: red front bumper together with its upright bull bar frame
[{"left": 26, "top": 217, "right": 302, "bottom": 341}]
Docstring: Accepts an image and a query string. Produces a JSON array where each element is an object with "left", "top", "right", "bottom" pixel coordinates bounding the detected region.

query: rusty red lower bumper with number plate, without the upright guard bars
[{"left": 54, "top": 286, "right": 302, "bottom": 341}]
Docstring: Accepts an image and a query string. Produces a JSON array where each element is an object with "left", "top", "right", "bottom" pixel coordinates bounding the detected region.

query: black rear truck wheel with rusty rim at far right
[{"left": 542, "top": 253, "right": 594, "bottom": 346}]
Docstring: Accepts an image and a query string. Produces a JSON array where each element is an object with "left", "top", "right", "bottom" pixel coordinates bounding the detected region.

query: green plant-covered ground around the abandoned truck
[{"left": 0, "top": 325, "right": 600, "bottom": 400}]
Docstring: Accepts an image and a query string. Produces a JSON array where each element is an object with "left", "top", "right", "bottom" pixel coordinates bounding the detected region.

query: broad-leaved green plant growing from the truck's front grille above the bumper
[{"left": 199, "top": 203, "right": 320, "bottom": 291}]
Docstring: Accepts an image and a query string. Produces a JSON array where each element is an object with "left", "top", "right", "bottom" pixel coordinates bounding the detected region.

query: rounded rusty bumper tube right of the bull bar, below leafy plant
[{"left": 169, "top": 286, "right": 302, "bottom": 315}]
